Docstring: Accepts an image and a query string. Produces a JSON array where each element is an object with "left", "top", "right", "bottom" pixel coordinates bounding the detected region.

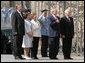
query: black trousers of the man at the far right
[{"left": 63, "top": 38, "right": 72, "bottom": 58}]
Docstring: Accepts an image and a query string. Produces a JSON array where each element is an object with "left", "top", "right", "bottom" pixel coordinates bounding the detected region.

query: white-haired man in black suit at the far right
[{"left": 60, "top": 9, "right": 74, "bottom": 59}]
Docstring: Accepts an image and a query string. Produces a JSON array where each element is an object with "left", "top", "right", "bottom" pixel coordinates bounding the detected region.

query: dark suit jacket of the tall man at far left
[{"left": 12, "top": 11, "right": 25, "bottom": 35}]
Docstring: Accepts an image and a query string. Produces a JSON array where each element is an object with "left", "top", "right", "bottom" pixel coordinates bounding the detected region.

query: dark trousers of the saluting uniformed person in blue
[{"left": 41, "top": 35, "right": 48, "bottom": 56}]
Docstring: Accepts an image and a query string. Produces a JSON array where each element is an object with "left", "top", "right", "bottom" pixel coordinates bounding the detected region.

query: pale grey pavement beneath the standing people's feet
[{"left": 1, "top": 53, "right": 84, "bottom": 62}]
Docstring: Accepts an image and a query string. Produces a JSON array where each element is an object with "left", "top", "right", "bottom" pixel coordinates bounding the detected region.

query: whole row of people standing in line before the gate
[{"left": 11, "top": 4, "right": 74, "bottom": 60}]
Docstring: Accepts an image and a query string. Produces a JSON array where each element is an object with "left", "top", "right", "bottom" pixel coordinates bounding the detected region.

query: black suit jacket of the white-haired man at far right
[{"left": 60, "top": 16, "right": 74, "bottom": 38}]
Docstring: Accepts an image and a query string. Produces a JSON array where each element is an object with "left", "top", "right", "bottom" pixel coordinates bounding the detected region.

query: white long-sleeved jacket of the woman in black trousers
[{"left": 31, "top": 19, "right": 41, "bottom": 37}]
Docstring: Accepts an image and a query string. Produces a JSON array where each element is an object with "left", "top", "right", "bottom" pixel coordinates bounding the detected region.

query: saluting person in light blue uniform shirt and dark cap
[{"left": 38, "top": 9, "right": 48, "bottom": 57}]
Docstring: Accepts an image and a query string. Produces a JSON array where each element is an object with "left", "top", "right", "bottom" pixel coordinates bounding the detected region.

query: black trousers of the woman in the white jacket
[{"left": 30, "top": 37, "right": 39, "bottom": 57}]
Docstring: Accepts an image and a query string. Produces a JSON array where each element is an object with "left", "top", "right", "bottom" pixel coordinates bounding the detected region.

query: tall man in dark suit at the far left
[{"left": 12, "top": 4, "right": 25, "bottom": 59}]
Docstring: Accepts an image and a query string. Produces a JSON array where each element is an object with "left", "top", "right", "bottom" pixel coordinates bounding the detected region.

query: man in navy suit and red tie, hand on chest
[{"left": 48, "top": 9, "right": 60, "bottom": 59}]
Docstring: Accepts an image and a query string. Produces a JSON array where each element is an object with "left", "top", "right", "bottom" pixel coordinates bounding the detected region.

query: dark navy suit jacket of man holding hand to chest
[{"left": 48, "top": 15, "right": 60, "bottom": 37}]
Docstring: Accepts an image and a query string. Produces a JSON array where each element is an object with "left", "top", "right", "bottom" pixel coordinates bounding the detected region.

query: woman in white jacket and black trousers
[{"left": 31, "top": 13, "right": 41, "bottom": 59}]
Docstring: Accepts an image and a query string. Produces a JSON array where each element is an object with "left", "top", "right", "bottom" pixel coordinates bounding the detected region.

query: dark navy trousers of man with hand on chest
[{"left": 49, "top": 36, "right": 59, "bottom": 59}]
